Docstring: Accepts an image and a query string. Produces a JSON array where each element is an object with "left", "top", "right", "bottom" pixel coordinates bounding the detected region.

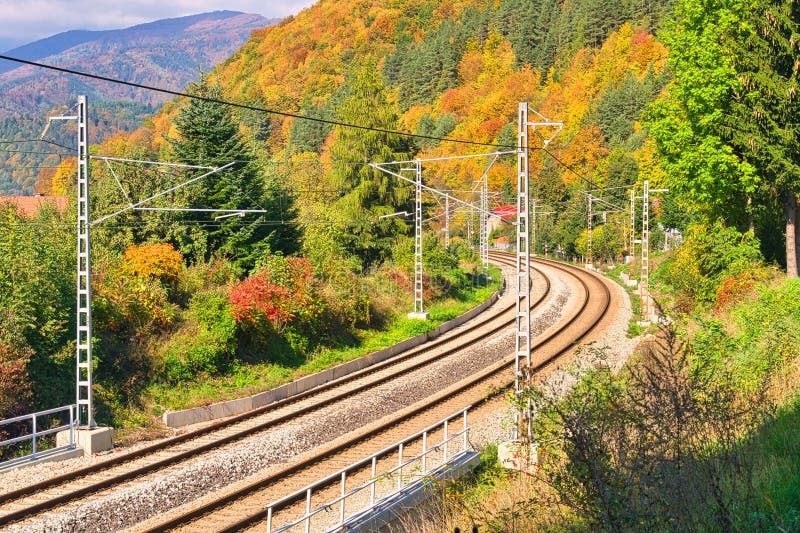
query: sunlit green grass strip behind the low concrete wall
[{"left": 137, "top": 269, "right": 502, "bottom": 418}]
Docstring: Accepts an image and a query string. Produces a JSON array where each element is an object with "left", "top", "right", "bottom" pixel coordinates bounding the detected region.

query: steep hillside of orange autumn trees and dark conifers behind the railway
[{"left": 100, "top": 0, "right": 671, "bottom": 270}]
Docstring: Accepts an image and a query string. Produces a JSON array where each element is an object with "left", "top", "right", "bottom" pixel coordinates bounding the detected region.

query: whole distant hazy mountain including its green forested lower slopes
[{"left": 0, "top": 11, "right": 277, "bottom": 194}]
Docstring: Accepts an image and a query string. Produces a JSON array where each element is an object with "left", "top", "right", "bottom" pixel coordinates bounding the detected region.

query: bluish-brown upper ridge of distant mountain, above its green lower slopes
[{"left": 0, "top": 11, "right": 274, "bottom": 116}]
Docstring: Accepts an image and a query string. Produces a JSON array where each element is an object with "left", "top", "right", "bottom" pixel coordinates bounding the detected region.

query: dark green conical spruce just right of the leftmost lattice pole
[{"left": 170, "top": 76, "right": 296, "bottom": 270}]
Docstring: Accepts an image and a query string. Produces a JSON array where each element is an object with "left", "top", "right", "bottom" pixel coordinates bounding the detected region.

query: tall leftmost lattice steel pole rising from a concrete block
[{"left": 75, "top": 96, "right": 96, "bottom": 429}]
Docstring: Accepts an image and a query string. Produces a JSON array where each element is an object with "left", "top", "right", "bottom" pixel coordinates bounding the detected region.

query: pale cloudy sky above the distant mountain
[{"left": 0, "top": 0, "right": 315, "bottom": 51}]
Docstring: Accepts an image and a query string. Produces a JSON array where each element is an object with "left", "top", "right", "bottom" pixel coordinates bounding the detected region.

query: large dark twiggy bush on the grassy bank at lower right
[{"left": 533, "top": 322, "right": 771, "bottom": 531}]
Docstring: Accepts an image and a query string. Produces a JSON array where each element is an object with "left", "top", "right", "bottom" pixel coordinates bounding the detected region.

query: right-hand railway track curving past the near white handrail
[{"left": 131, "top": 256, "right": 611, "bottom": 532}]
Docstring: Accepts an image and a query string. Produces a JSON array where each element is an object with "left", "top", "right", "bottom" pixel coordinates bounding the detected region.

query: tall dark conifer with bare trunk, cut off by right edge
[{"left": 722, "top": 0, "right": 800, "bottom": 278}]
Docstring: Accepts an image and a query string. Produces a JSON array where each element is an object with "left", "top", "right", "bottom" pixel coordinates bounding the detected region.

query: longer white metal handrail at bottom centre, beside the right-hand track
[{"left": 267, "top": 406, "right": 472, "bottom": 533}]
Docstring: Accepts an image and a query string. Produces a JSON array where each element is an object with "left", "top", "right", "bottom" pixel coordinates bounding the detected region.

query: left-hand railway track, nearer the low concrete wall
[{"left": 0, "top": 257, "right": 564, "bottom": 526}]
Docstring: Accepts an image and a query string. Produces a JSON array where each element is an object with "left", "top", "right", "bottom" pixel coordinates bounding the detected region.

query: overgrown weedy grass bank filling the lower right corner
[{"left": 421, "top": 272, "right": 800, "bottom": 532}]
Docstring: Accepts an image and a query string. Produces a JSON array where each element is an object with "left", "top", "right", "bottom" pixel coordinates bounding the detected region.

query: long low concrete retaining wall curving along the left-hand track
[{"left": 163, "top": 293, "right": 498, "bottom": 428}]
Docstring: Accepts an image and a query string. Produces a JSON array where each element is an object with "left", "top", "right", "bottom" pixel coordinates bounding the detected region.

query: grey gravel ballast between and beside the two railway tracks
[{"left": 0, "top": 260, "right": 634, "bottom": 531}]
